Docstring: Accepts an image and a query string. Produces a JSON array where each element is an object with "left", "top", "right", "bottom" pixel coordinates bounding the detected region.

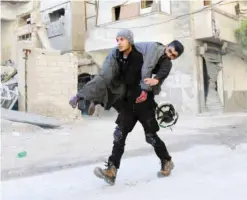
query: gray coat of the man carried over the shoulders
[{"left": 77, "top": 42, "right": 165, "bottom": 110}]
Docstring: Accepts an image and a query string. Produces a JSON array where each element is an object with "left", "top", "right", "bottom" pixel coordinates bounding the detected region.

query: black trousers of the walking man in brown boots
[{"left": 108, "top": 99, "right": 171, "bottom": 169}]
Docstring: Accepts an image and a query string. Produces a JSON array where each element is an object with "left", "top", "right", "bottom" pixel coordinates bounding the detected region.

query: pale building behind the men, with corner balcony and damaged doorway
[{"left": 85, "top": 0, "right": 247, "bottom": 113}]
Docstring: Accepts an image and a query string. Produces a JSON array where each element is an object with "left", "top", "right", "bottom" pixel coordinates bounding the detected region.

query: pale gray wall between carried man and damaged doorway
[{"left": 156, "top": 38, "right": 199, "bottom": 114}]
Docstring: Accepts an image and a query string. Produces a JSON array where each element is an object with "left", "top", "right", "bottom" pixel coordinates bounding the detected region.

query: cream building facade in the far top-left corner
[{"left": 1, "top": 1, "right": 38, "bottom": 63}]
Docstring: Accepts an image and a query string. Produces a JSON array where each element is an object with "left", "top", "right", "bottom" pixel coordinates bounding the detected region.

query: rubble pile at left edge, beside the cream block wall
[{"left": 0, "top": 62, "right": 19, "bottom": 109}]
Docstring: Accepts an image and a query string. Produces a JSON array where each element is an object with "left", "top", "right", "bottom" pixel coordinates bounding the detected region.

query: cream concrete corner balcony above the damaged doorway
[{"left": 194, "top": 9, "right": 238, "bottom": 43}]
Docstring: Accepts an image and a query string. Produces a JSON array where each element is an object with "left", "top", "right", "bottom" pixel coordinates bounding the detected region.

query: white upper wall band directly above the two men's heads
[{"left": 85, "top": 0, "right": 191, "bottom": 52}]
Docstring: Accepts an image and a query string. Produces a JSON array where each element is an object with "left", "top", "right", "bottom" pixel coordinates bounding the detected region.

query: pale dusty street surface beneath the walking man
[{"left": 2, "top": 115, "right": 247, "bottom": 200}]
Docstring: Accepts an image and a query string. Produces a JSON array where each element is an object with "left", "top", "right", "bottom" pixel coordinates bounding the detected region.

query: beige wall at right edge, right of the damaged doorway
[{"left": 223, "top": 54, "right": 247, "bottom": 112}]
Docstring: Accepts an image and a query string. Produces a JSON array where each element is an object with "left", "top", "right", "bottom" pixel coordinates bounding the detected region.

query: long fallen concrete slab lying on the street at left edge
[{"left": 1, "top": 108, "right": 62, "bottom": 128}]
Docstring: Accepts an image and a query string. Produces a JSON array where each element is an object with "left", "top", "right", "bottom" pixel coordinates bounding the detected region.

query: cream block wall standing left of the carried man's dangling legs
[{"left": 23, "top": 49, "right": 78, "bottom": 119}]
